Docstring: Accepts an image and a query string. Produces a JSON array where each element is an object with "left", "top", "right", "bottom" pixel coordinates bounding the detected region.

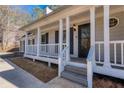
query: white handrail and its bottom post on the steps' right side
[{"left": 87, "top": 46, "right": 95, "bottom": 88}]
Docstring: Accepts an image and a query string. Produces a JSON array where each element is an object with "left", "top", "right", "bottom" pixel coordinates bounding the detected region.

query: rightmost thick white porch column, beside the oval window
[{"left": 104, "top": 5, "right": 110, "bottom": 68}]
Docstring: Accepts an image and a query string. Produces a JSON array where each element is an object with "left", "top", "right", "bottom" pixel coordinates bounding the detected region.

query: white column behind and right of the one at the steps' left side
[{"left": 66, "top": 16, "right": 70, "bottom": 62}]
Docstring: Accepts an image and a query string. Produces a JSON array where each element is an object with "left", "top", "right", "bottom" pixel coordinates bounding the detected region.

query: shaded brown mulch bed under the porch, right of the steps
[{"left": 93, "top": 74, "right": 124, "bottom": 88}]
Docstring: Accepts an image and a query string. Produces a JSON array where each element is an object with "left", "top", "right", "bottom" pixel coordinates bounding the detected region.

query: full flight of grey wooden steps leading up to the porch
[{"left": 61, "top": 65, "right": 87, "bottom": 87}]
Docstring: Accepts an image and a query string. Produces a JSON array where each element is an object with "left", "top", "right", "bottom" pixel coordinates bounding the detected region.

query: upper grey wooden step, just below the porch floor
[{"left": 65, "top": 65, "right": 87, "bottom": 76}]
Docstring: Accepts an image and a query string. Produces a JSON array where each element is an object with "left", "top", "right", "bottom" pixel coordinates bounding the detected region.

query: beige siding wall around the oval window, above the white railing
[{"left": 96, "top": 7, "right": 124, "bottom": 41}]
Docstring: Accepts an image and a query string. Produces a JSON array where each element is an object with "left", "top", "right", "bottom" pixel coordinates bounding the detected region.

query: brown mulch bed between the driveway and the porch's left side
[{"left": 10, "top": 57, "right": 58, "bottom": 82}]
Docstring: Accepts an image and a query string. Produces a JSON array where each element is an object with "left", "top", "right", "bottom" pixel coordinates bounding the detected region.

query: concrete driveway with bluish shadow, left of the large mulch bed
[{"left": 0, "top": 58, "right": 47, "bottom": 88}]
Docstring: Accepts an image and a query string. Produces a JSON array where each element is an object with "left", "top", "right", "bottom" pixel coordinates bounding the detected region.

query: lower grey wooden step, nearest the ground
[{"left": 61, "top": 71, "right": 87, "bottom": 87}]
